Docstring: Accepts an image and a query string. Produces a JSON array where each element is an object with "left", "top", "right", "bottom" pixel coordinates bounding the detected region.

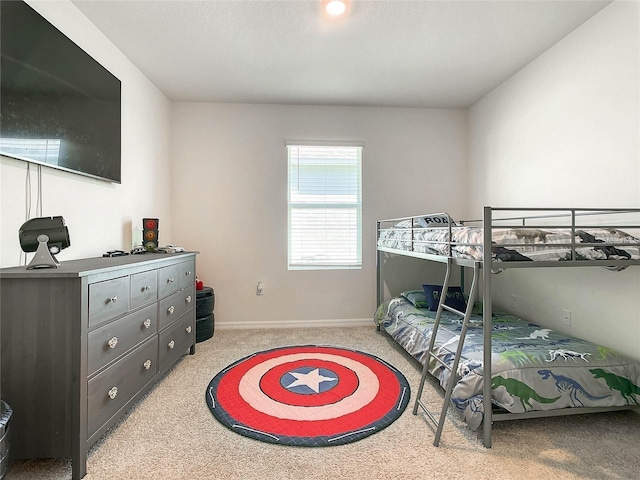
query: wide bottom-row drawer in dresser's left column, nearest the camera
[{"left": 87, "top": 335, "right": 158, "bottom": 438}]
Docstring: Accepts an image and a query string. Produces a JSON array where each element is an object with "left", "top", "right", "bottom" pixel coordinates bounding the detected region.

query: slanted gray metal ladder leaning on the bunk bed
[{"left": 413, "top": 258, "right": 481, "bottom": 447}]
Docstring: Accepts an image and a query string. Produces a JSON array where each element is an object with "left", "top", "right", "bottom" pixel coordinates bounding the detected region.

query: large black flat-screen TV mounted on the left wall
[{"left": 0, "top": 0, "right": 121, "bottom": 183}]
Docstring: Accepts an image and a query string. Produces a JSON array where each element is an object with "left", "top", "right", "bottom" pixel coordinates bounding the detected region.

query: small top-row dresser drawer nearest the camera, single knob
[{"left": 89, "top": 276, "right": 129, "bottom": 327}]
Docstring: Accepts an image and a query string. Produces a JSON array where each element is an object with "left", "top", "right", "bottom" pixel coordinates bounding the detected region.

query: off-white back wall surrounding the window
[{"left": 172, "top": 103, "right": 466, "bottom": 327}]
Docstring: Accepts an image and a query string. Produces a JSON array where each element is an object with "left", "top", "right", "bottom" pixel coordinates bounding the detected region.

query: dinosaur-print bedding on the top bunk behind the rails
[{"left": 378, "top": 224, "right": 640, "bottom": 262}]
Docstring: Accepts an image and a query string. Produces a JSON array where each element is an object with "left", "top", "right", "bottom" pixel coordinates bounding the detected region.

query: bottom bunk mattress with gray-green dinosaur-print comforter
[{"left": 375, "top": 291, "right": 640, "bottom": 429}]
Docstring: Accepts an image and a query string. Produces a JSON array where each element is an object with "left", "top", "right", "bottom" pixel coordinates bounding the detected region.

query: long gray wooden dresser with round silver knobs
[{"left": 0, "top": 252, "right": 196, "bottom": 480}]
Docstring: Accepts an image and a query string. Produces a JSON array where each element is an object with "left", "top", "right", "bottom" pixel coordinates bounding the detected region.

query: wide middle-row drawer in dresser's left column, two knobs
[{"left": 87, "top": 304, "right": 158, "bottom": 375}]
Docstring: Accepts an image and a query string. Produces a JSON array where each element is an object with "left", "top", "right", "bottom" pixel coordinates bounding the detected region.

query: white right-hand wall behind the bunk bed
[{"left": 468, "top": 1, "right": 640, "bottom": 359}]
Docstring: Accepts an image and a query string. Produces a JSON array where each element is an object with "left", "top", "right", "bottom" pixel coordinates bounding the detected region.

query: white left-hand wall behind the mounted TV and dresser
[{"left": 0, "top": 0, "right": 172, "bottom": 267}]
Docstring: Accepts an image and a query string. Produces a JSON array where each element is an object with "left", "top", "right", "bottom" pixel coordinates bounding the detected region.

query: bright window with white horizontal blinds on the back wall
[{"left": 287, "top": 142, "right": 363, "bottom": 270}]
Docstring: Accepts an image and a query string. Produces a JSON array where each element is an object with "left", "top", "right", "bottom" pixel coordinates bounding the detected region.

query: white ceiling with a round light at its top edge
[{"left": 73, "top": 0, "right": 610, "bottom": 108}]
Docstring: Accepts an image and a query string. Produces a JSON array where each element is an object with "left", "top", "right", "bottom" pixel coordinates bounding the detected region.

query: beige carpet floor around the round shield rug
[{"left": 7, "top": 326, "right": 640, "bottom": 480}]
